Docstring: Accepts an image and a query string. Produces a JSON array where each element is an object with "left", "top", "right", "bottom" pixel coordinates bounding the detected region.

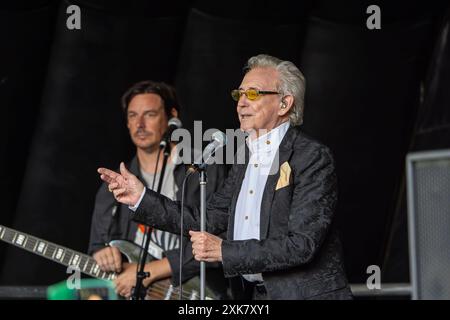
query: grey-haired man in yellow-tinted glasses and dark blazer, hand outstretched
[{"left": 98, "top": 55, "right": 352, "bottom": 300}]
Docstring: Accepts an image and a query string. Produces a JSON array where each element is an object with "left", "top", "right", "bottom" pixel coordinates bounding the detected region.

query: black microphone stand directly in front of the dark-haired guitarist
[{"left": 131, "top": 143, "right": 170, "bottom": 300}]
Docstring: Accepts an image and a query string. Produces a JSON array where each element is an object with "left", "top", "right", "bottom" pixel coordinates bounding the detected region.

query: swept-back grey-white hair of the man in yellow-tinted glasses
[{"left": 244, "top": 54, "right": 306, "bottom": 125}]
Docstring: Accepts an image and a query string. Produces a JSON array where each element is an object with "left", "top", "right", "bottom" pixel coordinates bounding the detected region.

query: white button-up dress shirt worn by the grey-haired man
[{"left": 234, "top": 121, "right": 290, "bottom": 281}]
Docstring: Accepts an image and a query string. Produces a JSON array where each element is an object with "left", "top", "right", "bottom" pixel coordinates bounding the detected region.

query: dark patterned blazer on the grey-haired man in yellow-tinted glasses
[{"left": 134, "top": 127, "right": 352, "bottom": 299}]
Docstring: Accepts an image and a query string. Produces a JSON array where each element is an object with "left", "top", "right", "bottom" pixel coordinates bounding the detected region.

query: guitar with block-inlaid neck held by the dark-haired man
[{"left": 0, "top": 225, "right": 212, "bottom": 300}]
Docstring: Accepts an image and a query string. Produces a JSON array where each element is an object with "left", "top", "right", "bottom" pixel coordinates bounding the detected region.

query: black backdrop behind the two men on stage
[{"left": 0, "top": 0, "right": 450, "bottom": 285}]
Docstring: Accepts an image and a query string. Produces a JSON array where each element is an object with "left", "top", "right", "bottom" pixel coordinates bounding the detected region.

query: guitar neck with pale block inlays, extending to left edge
[{"left": 0, "top": 225, "right": 116, "bottom": 280}]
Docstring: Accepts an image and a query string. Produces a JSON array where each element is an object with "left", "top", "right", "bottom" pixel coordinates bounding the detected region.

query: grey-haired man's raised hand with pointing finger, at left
[{"left": 97, "top": 162, "right": 144, "bottom": 206}]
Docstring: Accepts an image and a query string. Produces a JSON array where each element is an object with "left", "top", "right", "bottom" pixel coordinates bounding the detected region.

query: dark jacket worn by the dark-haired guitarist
[{"left": 88, "top": 157, "right": 226, "bottom": 297}]
